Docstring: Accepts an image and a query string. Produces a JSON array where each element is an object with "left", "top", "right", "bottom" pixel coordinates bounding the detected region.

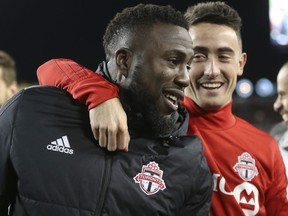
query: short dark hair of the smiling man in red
[{"left": 184, "top": 1, "right": 242, "bottom": 46}]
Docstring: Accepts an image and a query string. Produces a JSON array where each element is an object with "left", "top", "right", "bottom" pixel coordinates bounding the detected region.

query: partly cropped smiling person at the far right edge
[{"left": 270, "top": 61, "right": 288, "bottom": 176}]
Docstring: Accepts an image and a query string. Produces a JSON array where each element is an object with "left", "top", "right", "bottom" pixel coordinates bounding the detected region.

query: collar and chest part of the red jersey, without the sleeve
[{"left": 184, "top": 97, "right": 288, "bottom": 216}]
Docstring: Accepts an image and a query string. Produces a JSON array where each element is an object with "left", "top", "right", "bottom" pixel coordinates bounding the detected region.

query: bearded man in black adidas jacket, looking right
[{"left": 0, "top": 4, "right": 212, "bottom": 216}]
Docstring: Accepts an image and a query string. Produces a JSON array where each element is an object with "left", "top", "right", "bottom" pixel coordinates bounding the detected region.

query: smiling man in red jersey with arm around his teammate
[{"left": 38, "top": 2, "right": 288, "bottom": 216}]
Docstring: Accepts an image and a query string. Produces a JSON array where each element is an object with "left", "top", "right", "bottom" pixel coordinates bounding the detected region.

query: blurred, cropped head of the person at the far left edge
[{"left": 0, "top": 50, "right": 18, "bottom": 106}]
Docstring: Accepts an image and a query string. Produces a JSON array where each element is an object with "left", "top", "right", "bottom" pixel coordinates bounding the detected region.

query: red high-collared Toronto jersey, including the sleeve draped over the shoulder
[{"left": 37, "top": 59, "right": 288, "bottom": 216}]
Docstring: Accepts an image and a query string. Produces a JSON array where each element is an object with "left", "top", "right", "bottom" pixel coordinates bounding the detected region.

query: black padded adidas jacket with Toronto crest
[{"left": 0, "top": 87, "right": 212, "bottom": 216}]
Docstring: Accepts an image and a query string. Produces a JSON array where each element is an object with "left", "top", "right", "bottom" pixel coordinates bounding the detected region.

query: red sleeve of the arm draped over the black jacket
[{"left": 37, "top": 59, "right": 118, "bottom": 110}]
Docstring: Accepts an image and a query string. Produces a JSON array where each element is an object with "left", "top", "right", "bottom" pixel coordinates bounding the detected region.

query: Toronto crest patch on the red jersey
[{"left": 233, "top": 152, "right": 258, "bottom": 181}]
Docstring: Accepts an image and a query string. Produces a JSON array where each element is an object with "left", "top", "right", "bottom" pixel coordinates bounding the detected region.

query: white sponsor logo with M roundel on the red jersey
[{"left": 213, "top": 173, "right": 259, "bottom": 215}]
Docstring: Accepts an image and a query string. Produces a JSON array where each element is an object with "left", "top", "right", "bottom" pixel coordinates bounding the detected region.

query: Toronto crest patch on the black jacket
[{"left": 133, "top": 161, "right": 166, "bottom": 195}]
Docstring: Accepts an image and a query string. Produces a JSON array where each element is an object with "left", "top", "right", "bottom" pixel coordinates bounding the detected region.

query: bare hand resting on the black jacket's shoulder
[{"left": 89, "top": 98, "right": 130, "bottom": 151}]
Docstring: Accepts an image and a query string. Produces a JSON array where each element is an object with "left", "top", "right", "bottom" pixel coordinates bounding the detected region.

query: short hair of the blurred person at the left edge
[{"left": 0, "top": 50, "right": 17, "bottom": 86}]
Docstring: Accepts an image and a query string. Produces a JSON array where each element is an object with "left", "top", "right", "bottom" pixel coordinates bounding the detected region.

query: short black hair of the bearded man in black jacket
[{"left": 103, "top": 3, "right": 189, "bottom": 55}]
